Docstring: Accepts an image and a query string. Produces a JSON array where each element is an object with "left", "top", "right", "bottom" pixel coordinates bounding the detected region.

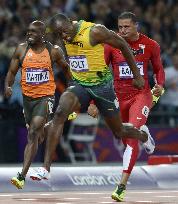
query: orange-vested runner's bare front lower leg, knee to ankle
[{"left": 21, "top": 116, "right": 46, "bottom": 177}]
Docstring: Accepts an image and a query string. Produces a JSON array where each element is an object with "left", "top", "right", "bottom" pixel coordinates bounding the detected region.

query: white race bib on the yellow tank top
[{"left": 69, "top": 55, "right": 88, "bottom": 72}]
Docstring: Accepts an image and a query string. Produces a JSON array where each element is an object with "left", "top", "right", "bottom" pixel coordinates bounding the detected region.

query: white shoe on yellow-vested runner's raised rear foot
[{"left": 140, "top": 125, "right": 155, "bottom": 154}]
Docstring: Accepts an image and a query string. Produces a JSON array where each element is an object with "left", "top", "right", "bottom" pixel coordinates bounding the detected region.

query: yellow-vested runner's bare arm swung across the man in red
[{"left": 90, "top": 25, "right": 144, "bottom": 88}]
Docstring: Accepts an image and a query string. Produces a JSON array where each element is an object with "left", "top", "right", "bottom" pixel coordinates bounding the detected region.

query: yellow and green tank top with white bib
[{"left": 65, "top": 20, "right": 112, "bottom": 86}]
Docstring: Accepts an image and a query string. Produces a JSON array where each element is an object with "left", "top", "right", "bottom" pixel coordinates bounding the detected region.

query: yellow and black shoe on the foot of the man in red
[{"left": 111, "top": 184, "right": 126, "bottom": 202}]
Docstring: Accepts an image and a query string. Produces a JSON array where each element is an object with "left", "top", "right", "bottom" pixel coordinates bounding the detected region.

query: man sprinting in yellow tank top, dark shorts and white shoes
[{"left": 33, "top": 14, "right": 154, "bottom": 190}]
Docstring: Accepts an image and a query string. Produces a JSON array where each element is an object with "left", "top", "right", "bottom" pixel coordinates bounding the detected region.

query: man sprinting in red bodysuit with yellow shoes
[{"left": 105, "top": 12, "right": 165, "bottom": 201}]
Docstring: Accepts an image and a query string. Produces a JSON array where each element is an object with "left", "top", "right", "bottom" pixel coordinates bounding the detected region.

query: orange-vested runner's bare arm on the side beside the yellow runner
[{"left": 52, "top": 45, "right": 71, "bottom": 80}]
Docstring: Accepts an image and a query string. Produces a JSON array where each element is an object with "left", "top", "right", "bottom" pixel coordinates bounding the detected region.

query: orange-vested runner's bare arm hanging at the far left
[{"left": 5, "top": 45, "right": 21, "bottom": 97}]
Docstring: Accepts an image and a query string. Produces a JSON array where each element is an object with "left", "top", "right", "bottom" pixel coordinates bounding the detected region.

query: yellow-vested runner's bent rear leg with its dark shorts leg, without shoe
[{"left": 89, "top": 81, "right": 148, "bottom": 142}]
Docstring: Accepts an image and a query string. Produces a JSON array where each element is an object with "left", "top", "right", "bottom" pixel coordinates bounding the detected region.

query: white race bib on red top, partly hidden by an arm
[{"left": 119, "top": 62, "right": 144, "bottom": 79}]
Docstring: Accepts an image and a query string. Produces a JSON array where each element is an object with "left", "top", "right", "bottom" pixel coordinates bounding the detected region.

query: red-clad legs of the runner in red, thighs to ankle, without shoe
[{"left": 120, "top": 93, "right": 152, "bottom": 185}]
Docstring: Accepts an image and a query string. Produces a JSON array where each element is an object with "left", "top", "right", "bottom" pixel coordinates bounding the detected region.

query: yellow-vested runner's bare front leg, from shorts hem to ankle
[{"left": 44, "top": 91, "right": 80, "bottom": 171}]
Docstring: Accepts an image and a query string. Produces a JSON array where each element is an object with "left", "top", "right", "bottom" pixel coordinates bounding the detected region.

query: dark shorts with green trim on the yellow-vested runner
[{"left": 68, "top": 80, "right": 119, "bottom": 116}]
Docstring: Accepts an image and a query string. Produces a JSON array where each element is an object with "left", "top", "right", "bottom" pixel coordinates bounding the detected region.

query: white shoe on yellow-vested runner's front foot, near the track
[{"left": 30, "top": 167, "right": 49, "bottom": 181}]
